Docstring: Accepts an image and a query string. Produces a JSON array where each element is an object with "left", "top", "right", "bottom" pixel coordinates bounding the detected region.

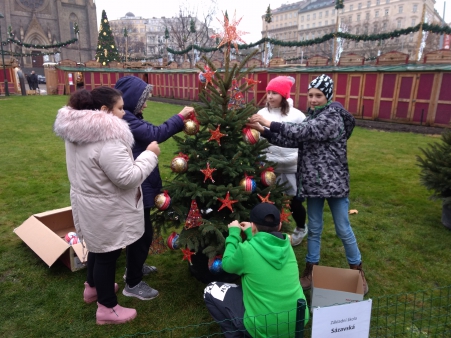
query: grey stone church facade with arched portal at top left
[{"left": 0, "top": 0, "right": 98, "bottom": 72}]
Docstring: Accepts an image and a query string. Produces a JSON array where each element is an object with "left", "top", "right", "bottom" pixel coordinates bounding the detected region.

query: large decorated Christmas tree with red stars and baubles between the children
[{"left": 152, "top": 11, "right": 290, "bottom": 282}]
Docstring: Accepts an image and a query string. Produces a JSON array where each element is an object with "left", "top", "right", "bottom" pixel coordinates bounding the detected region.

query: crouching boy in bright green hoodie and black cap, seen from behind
[{"left": 204, "top": 203, "right": 309, "bottom": 337}]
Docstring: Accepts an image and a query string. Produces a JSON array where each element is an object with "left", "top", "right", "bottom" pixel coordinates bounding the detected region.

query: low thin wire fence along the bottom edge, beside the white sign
[{"left": 123, "top": 286, "right": 451, "bottom": 338}]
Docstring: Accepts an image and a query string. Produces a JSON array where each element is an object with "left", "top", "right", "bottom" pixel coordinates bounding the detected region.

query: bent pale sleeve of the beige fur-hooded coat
[{"left": 99, "top": 141, "right": 158, "bottom": 189}]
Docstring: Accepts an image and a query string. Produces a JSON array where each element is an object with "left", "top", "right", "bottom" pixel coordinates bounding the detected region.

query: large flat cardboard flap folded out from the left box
[{"left": 14, "top": 216, "right": 70, "bottom": 267}]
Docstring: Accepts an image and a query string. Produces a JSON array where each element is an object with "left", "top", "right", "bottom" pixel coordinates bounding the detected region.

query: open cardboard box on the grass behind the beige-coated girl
[{"left": 14, "top": 207, "right": 88, "bottom": 271}]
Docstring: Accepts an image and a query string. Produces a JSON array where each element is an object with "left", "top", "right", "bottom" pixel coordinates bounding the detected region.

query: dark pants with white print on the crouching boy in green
[{"left": 204, "top": 282, "right": 251, "bottom": 338}]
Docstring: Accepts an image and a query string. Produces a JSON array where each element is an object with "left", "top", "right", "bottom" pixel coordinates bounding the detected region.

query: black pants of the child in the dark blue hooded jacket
[{"left": 125, "top": 208, "right": 153, "bottom": 287}]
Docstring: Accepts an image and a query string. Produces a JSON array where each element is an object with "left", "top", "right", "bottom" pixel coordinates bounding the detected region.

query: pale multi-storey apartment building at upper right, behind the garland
[{"left": 263, "top": 0, "right": 441, "bottom": 59}]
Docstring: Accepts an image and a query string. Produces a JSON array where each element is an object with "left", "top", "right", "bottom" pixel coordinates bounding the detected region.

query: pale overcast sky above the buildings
[{"left": 95, "top": 0, "right": 451, "bottom": 43}]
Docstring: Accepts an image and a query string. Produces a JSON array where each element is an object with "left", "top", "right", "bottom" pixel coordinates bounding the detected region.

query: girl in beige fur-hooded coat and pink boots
[{"left": 54, "top": 87, "right": 160, "bottom": 324}]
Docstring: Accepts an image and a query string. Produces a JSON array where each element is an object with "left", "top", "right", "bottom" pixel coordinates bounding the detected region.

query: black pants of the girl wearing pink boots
[{"left": 86, "top": 249, "right": 121, "bottom": 308}]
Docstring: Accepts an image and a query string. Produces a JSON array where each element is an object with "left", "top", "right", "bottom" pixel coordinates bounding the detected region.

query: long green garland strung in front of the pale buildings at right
[{"left": 167, "top": 23, "right": 451, "bottom": 55}]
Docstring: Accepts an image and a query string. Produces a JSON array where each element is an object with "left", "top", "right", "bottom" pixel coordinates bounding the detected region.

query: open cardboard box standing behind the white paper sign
[{"left": 311, "top": 265, "right": 363, "bottom": 309}]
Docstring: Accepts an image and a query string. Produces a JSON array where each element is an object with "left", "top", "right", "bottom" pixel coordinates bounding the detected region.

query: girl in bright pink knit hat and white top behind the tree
[{"left": 258, "top": 76, "right": 307, "bottom": 246}]
